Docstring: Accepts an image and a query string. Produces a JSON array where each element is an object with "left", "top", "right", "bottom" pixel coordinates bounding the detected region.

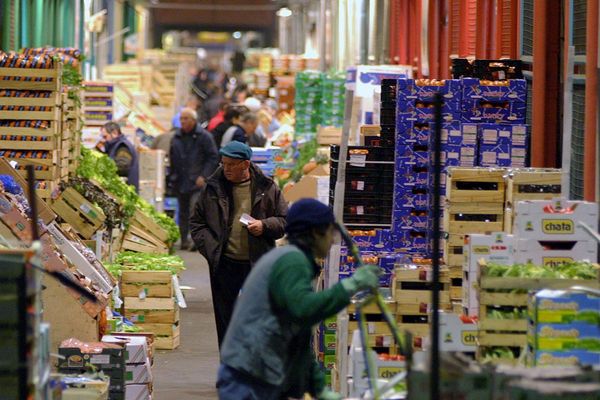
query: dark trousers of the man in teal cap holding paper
[{"left": 210, "top": 256, "right": 250, "bottom": 349}]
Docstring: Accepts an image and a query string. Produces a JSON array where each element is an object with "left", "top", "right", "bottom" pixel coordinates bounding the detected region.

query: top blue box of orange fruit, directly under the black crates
[{"left": 462, "top": 78, "right": 527, "bottom": 103}]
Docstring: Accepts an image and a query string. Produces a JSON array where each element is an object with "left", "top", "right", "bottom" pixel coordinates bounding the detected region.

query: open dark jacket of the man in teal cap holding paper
[{"left": 190, "top": 164, "right": 287, "bottom": 268}]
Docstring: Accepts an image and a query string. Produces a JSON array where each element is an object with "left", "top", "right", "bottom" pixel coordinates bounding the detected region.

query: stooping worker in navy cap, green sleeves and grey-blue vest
[{"left": 217, "top": 199, "right": 379, "bottom": 400}]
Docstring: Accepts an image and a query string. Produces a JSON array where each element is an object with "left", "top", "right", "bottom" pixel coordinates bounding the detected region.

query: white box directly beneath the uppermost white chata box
[{"left": 515, "top": 239, "right": 598, "bottom": 266}]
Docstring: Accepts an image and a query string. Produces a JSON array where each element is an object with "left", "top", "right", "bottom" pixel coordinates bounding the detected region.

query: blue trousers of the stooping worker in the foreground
[{"left": 217, "top": 364, "right": 281, "bottom": 400}]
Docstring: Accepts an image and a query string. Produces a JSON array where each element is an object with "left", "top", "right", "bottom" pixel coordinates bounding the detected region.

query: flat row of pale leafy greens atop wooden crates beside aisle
[{"left": 105, "top": 251, "right": 185, "bottom": 277}]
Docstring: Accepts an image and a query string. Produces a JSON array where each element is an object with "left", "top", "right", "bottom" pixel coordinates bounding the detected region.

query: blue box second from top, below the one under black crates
[{"left": 461, "top": 99, "right": 527, "bottom": 124}]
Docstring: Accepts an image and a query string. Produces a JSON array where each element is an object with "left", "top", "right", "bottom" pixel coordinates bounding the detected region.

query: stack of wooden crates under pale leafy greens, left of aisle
[{"left": 121, "top": 271, "right": 179, "bottom": 350}]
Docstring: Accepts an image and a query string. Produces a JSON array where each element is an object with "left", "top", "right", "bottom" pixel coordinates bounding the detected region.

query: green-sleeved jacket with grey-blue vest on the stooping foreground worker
[{"left": 221, "top": 245, "right": 350, "bottom": 397}]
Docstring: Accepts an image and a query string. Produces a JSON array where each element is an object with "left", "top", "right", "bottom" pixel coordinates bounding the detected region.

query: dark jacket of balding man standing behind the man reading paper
[{"left": 169, "top": 125, "right": 219, "bottom": 193}]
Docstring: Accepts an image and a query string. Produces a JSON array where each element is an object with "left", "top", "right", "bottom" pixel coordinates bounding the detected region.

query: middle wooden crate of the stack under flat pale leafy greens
[{"left": 124, "top": 297, "right": 179, "bottom": 324}]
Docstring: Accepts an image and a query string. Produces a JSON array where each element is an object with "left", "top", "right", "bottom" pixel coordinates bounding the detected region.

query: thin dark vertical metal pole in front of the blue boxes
[{"left": 430, "top": 93, "right": 443, "bottom": 400}]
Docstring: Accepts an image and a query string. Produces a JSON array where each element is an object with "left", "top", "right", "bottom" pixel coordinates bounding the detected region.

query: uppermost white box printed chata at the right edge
[{"left": 513, "top": 199, "right": 598, "bottom": 241}]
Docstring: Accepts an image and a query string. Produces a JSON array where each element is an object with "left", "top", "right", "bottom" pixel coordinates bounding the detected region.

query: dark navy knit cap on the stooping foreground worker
[{"left": 285, "top": 199, "right": 335, "bottom": 233}]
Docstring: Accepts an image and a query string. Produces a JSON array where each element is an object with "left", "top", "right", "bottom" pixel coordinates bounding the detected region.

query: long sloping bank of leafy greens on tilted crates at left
[{"left": 77, "top": 148, "right": 179, "bottom": 243}]
